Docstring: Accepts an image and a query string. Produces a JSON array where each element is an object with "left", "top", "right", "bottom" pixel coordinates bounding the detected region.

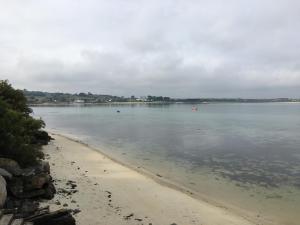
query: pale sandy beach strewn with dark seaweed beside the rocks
[{"left": 43, "top": 134, "right": 254, "bottom": 225}]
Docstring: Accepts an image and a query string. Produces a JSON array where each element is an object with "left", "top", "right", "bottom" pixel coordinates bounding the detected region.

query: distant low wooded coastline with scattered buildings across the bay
[{"left": 24, "top": 90, "right": 300, "bottom": 105}]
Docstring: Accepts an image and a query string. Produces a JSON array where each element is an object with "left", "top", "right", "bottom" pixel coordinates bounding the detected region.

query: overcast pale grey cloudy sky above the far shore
[{"left": 0, "top": 0, "right": 300, "bottom": 98}]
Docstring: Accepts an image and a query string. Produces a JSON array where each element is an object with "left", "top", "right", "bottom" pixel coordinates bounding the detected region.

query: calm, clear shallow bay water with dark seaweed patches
[{"left": 33, "top": 103, "right": 300, "bottom": 225}]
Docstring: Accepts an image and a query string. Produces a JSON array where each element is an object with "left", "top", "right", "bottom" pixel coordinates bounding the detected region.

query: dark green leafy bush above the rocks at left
[{"left": 0, "top": 80, "right": 45, "bottom": 166}]
